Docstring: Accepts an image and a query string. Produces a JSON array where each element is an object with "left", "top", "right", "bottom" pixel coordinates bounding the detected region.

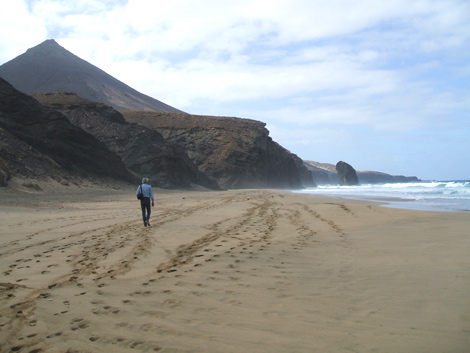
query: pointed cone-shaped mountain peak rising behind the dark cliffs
[{"left": 0, "top": 39, "right": 180, "bottom": 112}]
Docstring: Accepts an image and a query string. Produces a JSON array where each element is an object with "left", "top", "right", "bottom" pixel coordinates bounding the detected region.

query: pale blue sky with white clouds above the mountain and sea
[{"left": 0, "top": 0, "right": 470, "bottom": 180}]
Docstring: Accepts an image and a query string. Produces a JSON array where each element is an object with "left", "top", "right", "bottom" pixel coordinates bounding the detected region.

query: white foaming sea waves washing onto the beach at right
[{"left": 298, "top": 180, "right": 470, "bottom": 212}]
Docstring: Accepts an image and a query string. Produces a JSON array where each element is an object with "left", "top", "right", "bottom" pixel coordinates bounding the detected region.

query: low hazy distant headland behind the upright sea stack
[{"left": 304, "top": 161, "right": 420, "bottom": 185}]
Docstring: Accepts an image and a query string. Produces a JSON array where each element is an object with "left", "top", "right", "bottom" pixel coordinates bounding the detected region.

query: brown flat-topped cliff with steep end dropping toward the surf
[{"left": 123, "top": 112, "right": 314, "bottom": 189}]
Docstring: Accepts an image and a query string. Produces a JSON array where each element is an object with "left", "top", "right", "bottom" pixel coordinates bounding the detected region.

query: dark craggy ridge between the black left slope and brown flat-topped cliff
[{"left": 34, "top": 93, "right": 219, "bottom": 189}]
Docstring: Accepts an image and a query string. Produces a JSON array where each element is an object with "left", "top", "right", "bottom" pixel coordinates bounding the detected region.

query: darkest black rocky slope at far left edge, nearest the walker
[{"left": 0, "top": 79, "right": 131, "bottom": 184}]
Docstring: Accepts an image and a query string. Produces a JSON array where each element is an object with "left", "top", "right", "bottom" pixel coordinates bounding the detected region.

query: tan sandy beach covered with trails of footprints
[{"left": 0, "top": 187, "right": 470, "bottom": 353}]
